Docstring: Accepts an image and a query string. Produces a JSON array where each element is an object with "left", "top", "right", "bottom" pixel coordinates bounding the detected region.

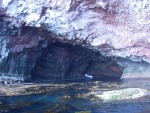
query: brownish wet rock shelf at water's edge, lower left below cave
[{"left": 0, "top": 83, "right": 73, "bottom": 96}]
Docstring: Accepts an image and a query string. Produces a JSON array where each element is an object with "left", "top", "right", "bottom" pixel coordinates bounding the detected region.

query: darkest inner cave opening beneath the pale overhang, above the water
[{"left": 31, "top": 41, "right": 122, "bottom": 81}]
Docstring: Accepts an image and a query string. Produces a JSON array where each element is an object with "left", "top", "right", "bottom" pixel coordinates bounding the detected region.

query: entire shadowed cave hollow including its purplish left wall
[{"left": 0, "top": 22, "right": 124, "bottom": 82}]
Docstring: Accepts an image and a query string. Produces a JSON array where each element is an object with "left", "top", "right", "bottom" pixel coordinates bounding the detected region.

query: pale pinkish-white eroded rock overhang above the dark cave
[{"left": 1, "top": 0, "right": 150, "bottom": 62}]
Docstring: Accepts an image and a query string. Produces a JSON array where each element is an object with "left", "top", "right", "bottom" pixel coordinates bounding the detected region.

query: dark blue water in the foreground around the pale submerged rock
[{"left": 0, "top": 79, "right": 150, "bottom": 113}]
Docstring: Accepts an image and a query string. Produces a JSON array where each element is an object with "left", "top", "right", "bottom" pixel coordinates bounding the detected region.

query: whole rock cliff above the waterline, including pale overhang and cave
[{"left": 0, "top": 0, "right": 150, "bottom": 81}]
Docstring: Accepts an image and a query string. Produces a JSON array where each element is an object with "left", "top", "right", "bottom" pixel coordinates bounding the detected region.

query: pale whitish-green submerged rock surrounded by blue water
[{"left": 94, "top": 88, "right": 150, "bottom": 101}]
